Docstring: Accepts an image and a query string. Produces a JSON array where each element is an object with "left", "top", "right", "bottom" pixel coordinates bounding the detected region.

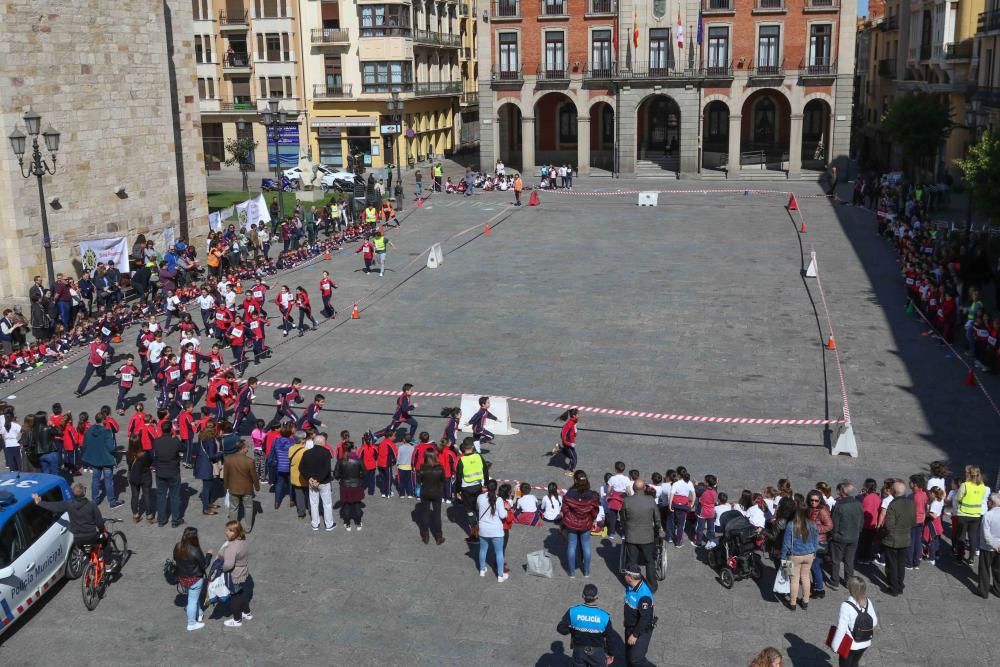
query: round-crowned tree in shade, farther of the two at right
[{"left": 882, "top": 93, "right": 955, "bottom": 176}]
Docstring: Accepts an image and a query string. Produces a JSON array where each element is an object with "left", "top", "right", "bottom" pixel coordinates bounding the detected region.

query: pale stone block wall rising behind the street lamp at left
[{"left": 0, "top": 0, "right": 208, "bottom": 303}]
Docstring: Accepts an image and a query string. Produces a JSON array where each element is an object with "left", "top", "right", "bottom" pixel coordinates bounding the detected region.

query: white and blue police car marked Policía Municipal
[{"left": 0, "top": 472, "right": 73, "bottom": 635}]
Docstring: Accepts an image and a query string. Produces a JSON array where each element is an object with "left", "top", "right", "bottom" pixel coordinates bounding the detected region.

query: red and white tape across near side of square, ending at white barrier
[{"left": 252, "top": 380, "right": 844, "bottom": 426}]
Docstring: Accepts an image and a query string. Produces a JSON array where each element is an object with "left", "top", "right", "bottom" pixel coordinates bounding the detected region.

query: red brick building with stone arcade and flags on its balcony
[{"left": 478, "top": 0, "right": 857, "bottom": 178}]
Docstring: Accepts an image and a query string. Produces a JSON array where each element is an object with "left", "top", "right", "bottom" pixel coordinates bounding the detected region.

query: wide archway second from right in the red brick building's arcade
[{"left": 740, "top": 90, "right": 792, "bottom": 169}]
